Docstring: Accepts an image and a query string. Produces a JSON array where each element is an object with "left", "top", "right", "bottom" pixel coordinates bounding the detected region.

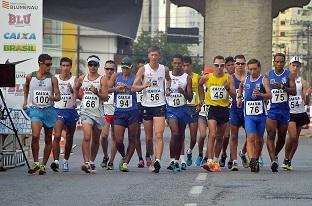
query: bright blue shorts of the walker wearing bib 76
[{"left": 245, "top": 115, "right": 266, "bottom": 137}]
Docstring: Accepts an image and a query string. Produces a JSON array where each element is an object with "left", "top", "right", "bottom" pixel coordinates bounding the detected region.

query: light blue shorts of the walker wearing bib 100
[{"left": 24, "top": 107, "right": 57, "bottom": 128}]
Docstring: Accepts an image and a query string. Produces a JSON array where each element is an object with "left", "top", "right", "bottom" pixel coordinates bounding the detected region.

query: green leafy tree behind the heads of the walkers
[{"left": 133, "top": 31, "right": 190, "bottom": 67}]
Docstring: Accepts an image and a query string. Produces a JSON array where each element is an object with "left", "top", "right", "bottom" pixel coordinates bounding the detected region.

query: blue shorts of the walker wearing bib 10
[{"left": 166, "top": 105, "right": 193, "bottom": 124}]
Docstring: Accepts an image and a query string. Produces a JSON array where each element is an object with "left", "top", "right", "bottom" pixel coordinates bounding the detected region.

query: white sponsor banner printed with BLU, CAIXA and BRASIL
[{"left": 0, "top": 0, "right": 43, "bottom": 133}]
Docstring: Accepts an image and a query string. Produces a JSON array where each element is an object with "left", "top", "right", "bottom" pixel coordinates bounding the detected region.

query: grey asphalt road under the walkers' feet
[{"left": 0, "top": 128, "right": 312, "bottom": 206}]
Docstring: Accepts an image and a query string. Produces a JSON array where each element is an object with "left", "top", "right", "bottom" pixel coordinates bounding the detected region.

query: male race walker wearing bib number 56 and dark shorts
[{"left": 134, "top": 47, "right": 170, "bottom": 173}]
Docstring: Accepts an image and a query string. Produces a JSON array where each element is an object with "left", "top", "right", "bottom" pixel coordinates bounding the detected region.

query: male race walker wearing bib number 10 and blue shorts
[{"left": 167, "top": 54, "right": 196, "bottom": 172}]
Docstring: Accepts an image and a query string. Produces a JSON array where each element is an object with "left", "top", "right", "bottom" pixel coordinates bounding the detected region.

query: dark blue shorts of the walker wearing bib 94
[{"left": 114, "top": 110, "right": 139, "bottom": 127}]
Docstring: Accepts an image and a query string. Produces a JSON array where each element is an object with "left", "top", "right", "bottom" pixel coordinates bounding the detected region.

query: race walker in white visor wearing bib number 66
[{"left": 75, "top": 55, "right": 108, "bottom": 173}]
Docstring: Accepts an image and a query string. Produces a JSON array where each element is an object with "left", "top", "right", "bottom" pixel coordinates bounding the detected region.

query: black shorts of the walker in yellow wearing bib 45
[{"left": 207, "top": 106, "right": 230, "bottom": 124}]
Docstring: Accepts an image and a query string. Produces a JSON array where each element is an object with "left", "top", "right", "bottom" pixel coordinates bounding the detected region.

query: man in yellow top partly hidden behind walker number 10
[{"left": 180, "top": 56, "right": 200, "bottom": 168}]
